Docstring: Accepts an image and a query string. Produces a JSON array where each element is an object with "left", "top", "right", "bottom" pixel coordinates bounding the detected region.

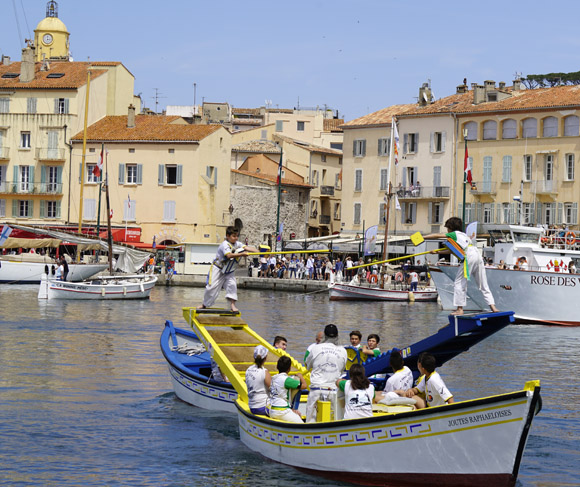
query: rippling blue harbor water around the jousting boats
[{"left": 0, "top": 286, "right": 580, "bottom": 487}]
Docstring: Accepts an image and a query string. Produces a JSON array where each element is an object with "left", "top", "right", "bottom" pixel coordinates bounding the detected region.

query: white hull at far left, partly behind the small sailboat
[{"left": 0, "top": 260, "right": 107, "bottom": 284}]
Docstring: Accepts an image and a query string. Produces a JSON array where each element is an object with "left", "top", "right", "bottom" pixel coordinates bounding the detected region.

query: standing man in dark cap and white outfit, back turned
[{"left": 306, "top": 324, "right": 347, "bottom": 423}]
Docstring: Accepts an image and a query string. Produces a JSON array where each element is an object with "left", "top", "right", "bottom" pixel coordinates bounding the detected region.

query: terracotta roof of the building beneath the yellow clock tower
[{"left": 0, "top": 61, "right": 107, "bottom": 90}]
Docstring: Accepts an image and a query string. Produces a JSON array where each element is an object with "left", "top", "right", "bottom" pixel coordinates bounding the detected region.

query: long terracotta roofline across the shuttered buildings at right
[{"left": 343, "top": 85, "right": 580, "bottom": 129}]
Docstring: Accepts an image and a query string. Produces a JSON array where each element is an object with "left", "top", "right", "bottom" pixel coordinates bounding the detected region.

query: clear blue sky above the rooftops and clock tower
[{"left": 0, "top": 0, "right": 580, "bottom": 121}]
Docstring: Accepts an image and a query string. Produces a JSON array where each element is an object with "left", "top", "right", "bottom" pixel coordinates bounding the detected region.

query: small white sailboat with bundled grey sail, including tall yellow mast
[{"left": 38, "top": 71, "right": 157, "bottom": 300}]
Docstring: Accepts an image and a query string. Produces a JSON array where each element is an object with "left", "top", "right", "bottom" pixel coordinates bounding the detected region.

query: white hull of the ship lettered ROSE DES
[{"left": 432, "top": 266, "right": 580, "bottom": 326}]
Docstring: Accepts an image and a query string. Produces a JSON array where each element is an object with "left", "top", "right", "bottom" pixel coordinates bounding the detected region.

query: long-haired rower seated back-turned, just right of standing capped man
[{"left": 336, "top": 364, "right": 375, "bottom": 419}]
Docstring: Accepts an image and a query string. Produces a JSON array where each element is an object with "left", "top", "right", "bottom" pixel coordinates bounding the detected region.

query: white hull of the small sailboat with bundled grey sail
[{"left": 39, "top": 276, "right": 157, "bottom": 300}]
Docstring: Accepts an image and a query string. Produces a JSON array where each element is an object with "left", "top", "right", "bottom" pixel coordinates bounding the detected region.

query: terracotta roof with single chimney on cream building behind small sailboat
[{"left": 68, "top": 115, "right": 222, "bottom": 142}]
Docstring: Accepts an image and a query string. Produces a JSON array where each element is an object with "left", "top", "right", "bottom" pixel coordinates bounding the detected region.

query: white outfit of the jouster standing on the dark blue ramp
[{"left": 446, "top": 231, "right": 495, "bottom": 308}]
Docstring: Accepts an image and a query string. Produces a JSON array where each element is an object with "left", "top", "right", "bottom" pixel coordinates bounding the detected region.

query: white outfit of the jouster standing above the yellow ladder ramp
[{"left": 203, "top": 240, "right": 243, "bottom": 308}]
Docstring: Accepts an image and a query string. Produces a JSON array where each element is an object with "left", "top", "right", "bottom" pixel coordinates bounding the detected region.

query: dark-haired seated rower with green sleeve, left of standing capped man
[{"left": 268, "top": 355, "right": 308, "bottom": 423}]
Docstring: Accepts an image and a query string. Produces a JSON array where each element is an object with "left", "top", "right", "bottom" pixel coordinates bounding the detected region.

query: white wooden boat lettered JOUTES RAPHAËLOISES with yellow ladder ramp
[{"left": 184, "top": 308, "right": 541, "bottom": 487}]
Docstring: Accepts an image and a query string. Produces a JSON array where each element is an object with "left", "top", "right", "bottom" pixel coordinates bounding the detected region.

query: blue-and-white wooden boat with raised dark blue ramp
[{"left": 167, "top": 308, "right": 513, "bottom": 412}]
